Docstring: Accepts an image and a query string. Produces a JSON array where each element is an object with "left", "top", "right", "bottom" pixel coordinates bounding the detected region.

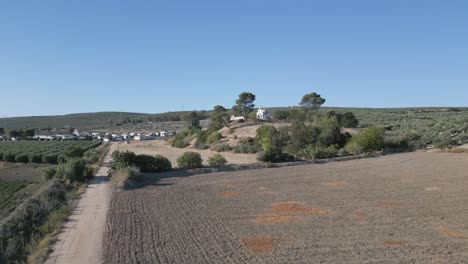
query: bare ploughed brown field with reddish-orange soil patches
[{"left": 104, "top": 152, "right": 468, "bottom": 264}]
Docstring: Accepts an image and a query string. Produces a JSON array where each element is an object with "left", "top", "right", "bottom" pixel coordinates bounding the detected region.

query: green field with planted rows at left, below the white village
[{"left": 0, "top": 141, "right": 101, "bottom": 164}]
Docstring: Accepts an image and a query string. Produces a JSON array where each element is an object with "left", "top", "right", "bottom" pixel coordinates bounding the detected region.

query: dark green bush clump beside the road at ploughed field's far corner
[{"left": 111, "top": 151, "right": 172, "bottom": 173}]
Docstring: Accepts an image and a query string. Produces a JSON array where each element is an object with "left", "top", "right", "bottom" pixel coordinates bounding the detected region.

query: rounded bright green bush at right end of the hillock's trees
[{"left": 346, "top": 126, "right": 385, "bottom": 155}]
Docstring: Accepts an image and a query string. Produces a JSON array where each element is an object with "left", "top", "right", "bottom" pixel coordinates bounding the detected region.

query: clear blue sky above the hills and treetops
[{"left": 0, "top": 0, "right": 468, "bottom": 117}]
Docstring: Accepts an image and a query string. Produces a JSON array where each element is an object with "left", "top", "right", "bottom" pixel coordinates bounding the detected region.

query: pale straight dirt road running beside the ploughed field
[{"left": 46, "top": 155, "right": 112, "bottom": 264}]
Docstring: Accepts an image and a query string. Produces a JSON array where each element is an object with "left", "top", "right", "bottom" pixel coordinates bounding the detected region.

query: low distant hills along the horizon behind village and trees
[{"left": 0, "top": 107, "right": 468, "bottom": 131}]
